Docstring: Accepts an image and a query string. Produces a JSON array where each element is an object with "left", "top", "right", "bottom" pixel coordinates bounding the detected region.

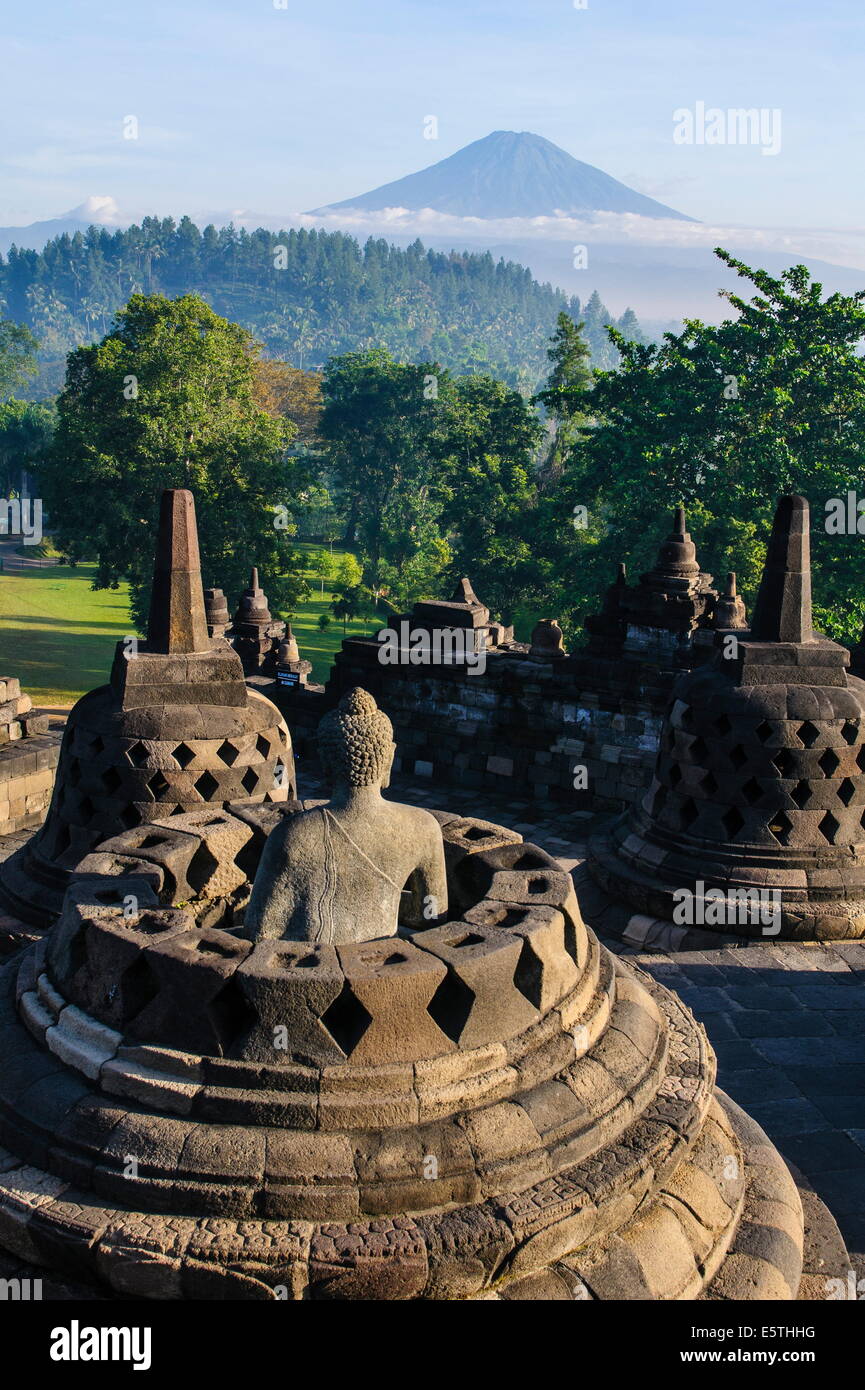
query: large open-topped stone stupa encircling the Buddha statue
[{"left": 0, "top": 695, "right": 848, "bottom": 1301}]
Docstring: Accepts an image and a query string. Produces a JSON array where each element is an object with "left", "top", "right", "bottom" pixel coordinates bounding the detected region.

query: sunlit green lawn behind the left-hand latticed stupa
[{"left": 0, "top": 543, "right": 382, "bottom": 705}]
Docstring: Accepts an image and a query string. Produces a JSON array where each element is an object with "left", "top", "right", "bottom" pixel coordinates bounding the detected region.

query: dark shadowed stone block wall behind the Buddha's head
[{"left": 268, "top": 638, "right": 679, "bottom": 810}]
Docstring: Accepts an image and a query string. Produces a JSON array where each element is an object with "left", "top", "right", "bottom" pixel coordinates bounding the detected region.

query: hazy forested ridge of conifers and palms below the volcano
[{"left": 0, "top": 217, "right": 641, "bottom": 398}]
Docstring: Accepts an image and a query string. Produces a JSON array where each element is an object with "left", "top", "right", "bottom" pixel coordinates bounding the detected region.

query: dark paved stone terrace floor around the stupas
[{"left": 333, "top": 773, "right": 865, "bottom": 1275}]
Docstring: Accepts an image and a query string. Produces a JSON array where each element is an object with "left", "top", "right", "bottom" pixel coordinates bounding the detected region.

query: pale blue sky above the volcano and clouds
[{"left": 0, "top": 0, "right": 865, "bottom": 229}]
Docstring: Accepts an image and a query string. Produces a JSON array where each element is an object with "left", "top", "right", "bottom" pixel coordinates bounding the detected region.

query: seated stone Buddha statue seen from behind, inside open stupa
[{"left": 245, "top": 688, "right": 448, "bottom": 944}]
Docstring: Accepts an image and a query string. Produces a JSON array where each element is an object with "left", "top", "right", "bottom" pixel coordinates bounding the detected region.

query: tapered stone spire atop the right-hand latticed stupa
[{"left": 751, "top": 496, "right": 814, "bottom": 642}]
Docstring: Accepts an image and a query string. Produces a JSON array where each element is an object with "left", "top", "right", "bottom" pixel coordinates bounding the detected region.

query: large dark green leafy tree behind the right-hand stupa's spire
[{"left": 545, "top": 249, "right": 865, "bottom": 638}]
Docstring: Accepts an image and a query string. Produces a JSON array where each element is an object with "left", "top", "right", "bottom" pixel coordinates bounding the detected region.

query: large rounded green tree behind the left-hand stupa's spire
[{"left": 42, "top": 296, "right": 309, "bottom": 626}]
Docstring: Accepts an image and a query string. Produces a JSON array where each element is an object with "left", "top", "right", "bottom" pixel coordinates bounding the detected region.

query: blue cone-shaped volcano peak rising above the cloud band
[{"left": 316, "top": 131, "right": 694, "bottom": 222}]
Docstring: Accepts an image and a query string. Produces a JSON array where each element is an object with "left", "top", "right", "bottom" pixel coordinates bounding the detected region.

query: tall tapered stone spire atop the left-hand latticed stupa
[{"left": 147, "top": 488, "right": 213, "bottom": 653}]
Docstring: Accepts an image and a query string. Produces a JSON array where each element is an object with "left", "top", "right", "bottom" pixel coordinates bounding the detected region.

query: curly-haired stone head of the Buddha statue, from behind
[{"left": 318, "top": 685, "right": 396, "bottom": 788}]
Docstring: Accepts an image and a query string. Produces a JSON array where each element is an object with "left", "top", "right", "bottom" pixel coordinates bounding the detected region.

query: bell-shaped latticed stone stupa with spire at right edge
[{"left": 590, "top": 496, "right": 865, "bottom": 940}]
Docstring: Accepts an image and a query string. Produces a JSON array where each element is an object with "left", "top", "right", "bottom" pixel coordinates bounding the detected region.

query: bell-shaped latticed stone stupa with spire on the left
[{"left": 0, "top": 489, "right": 295, "bottom": 929}]
